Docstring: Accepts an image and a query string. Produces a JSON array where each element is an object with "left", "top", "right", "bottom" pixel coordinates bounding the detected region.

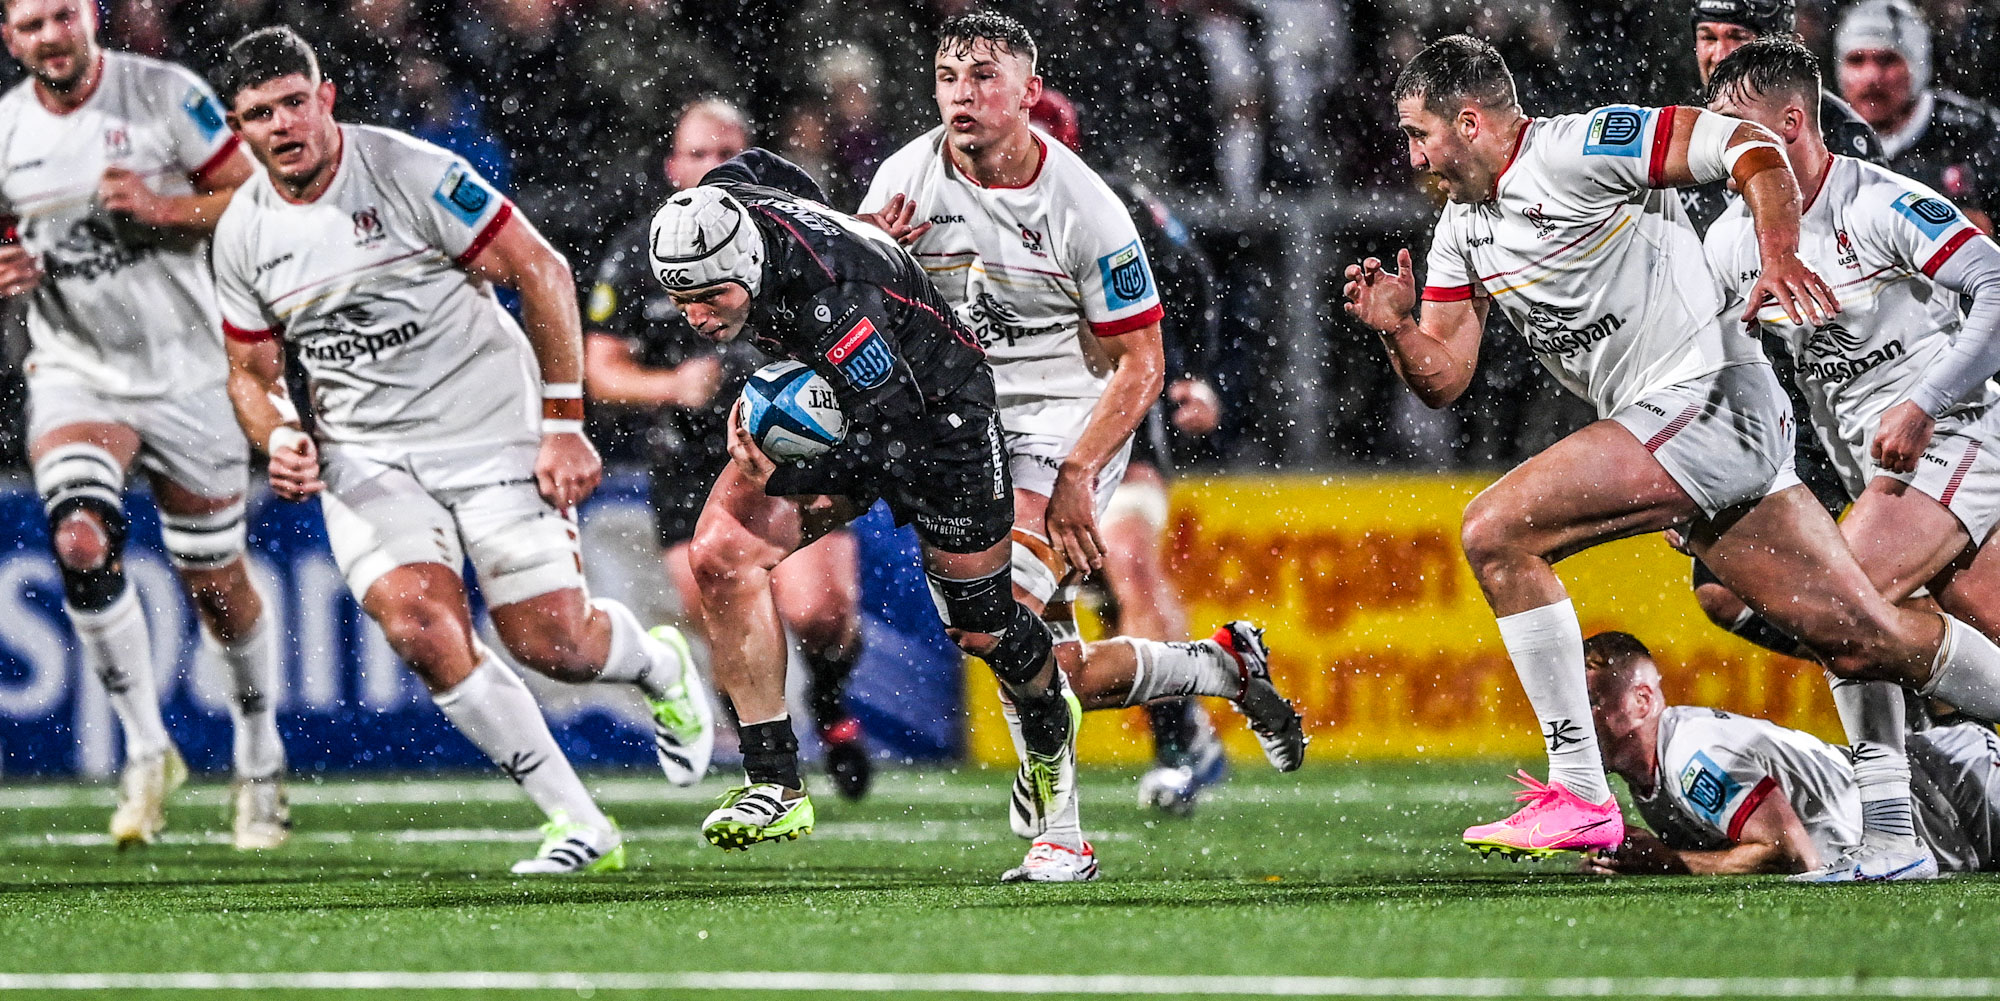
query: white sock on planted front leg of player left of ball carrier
[{"left": 430, "top": 655, "right": 610, "bottom": 831}]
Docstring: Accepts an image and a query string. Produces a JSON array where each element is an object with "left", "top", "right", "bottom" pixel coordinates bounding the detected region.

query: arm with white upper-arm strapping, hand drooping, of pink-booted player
[{"left": 1650, "top": 108, "right": 1840, "bottom": 326}]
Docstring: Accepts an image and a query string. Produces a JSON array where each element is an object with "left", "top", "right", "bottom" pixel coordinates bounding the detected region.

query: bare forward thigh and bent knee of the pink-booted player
[{"left": 1462, "top": 420, "right": 1700, "bottom": 569}]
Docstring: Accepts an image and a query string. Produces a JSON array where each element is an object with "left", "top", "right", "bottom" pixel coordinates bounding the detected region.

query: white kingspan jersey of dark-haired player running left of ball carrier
[{"left": 216, "top": 124, "right": 540, "bottom": 450}]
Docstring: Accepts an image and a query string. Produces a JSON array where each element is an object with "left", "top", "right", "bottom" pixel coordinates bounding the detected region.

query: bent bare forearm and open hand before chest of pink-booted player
[{"left": 1342, "top": 250, "right": 1488, "bottom": 408}]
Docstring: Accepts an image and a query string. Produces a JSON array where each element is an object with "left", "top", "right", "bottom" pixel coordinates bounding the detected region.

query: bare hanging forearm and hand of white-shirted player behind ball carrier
[{"left": 1044, "top": 322, "right": 1166, "bottom": 573}]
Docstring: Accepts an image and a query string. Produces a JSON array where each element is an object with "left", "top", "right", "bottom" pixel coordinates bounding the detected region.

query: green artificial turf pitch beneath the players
[{"left": 0, "top": 763, "right": 2000, "bottom": 997}]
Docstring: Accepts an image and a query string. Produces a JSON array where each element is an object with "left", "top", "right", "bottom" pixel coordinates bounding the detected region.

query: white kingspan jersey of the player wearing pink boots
[{"left": 1424, "top": 106, "right": 1762, "bottom": 416}]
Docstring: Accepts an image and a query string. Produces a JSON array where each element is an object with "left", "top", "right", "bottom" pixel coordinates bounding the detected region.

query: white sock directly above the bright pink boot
[{"left": 1500, "top": 599, "right": 1612, "bottom": 803}]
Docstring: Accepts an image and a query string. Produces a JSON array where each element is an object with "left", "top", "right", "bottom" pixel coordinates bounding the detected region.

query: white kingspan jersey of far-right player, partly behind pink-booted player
[{"left": 1706, "top": 156, "right": 2000, "bottom": 496}]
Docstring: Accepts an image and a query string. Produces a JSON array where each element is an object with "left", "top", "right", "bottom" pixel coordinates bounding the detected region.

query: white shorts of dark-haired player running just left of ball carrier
[{"left": 320, "top": 442, "right": 584, "bottom": 607}]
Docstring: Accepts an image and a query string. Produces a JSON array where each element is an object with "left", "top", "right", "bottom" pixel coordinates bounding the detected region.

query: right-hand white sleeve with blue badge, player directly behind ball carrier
[{"left": 1072, "top": 180, "right": 1166, "bottom": 336}]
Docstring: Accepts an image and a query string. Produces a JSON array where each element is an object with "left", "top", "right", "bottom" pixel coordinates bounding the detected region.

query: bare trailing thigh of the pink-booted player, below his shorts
[{"left": 1688, "top": 484, "right": 1892, "bottom": 640}]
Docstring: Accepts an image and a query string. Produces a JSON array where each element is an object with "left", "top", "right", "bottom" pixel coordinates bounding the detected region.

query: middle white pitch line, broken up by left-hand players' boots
[{"left": 0, "top": 821, "right": 1138, "bottom": 849}]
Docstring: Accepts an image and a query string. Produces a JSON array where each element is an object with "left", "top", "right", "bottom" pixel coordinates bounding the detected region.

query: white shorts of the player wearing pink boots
[{"left": 1610, "top": 362, "right": 1798, "bottom": 519}]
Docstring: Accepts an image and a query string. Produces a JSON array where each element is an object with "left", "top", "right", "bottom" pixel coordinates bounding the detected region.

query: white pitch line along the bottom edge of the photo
[{"left": 0, "top": 971, "right": 2000, "bottom": 997}]
